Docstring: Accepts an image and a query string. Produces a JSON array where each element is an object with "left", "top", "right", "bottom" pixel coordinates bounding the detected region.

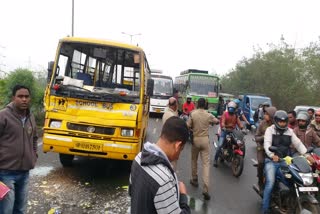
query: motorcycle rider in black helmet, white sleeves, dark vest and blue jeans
[{"left": 262, "top": 110, "right": 314, "bottom": 213}]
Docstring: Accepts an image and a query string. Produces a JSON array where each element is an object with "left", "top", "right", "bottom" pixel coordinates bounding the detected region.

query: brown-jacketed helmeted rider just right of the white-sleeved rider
[{"left": 293, "top": 112, "right": 320, "bottom": 153}]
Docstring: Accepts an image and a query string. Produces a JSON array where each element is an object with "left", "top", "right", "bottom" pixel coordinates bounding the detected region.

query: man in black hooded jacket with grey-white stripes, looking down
[{"left": 129, "top": 116, "right": 190, "bottom": 214}]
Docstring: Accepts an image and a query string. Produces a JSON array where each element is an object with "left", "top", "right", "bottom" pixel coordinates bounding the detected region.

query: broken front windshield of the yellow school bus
[{"left": 51, "top": 42, "right": 141, "bottom": 103}]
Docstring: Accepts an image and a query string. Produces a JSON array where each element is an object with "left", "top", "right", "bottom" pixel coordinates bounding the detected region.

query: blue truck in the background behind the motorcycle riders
[{"left": 239, "top": 94, "right": 272, "bottom": 128}]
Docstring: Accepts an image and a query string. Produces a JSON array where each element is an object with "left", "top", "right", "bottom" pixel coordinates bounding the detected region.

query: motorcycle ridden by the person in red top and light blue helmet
[{"left": 214, "top": 129, "right": 245, "bottom": 177}]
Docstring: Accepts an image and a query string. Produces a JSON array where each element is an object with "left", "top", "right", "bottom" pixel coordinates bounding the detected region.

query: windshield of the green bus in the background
[{"left": 189, "top": 75, "right": 217, "bottom": 95}]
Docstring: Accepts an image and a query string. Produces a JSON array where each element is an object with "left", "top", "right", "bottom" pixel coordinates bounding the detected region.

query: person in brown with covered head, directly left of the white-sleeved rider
[{"left": 255, "top": 106, "right": 277, "bottom": 192}]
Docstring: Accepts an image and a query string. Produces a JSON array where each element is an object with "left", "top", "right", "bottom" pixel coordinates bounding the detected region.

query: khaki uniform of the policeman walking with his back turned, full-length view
[{"left": 187, "top": 109, "right": 219, "bottom": 193}]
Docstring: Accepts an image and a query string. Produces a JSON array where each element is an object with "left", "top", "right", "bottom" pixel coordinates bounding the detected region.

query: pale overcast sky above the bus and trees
[{"left": 0, "top": 0, "right": 320, "bottom": 77}]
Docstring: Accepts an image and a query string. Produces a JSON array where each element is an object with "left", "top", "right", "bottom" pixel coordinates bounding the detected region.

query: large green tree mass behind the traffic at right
[{"left": 222, "top": 37, "right": 320, "bottom": 110}]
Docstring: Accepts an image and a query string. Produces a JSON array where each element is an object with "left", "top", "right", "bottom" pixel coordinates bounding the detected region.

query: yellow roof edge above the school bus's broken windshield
[{"left": 59, "top": 37, "right": 143, "bottom": 52}]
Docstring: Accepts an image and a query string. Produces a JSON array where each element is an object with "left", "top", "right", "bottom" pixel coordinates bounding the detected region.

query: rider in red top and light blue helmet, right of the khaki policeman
[{"left": 213, "top": 101, "right": 244, "bottom": 167}]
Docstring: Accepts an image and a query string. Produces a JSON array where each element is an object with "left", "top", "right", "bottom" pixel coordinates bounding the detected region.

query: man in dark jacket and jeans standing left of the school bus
[{"left": 0, "top": 85, "right": 38, "bottom": 214}]
